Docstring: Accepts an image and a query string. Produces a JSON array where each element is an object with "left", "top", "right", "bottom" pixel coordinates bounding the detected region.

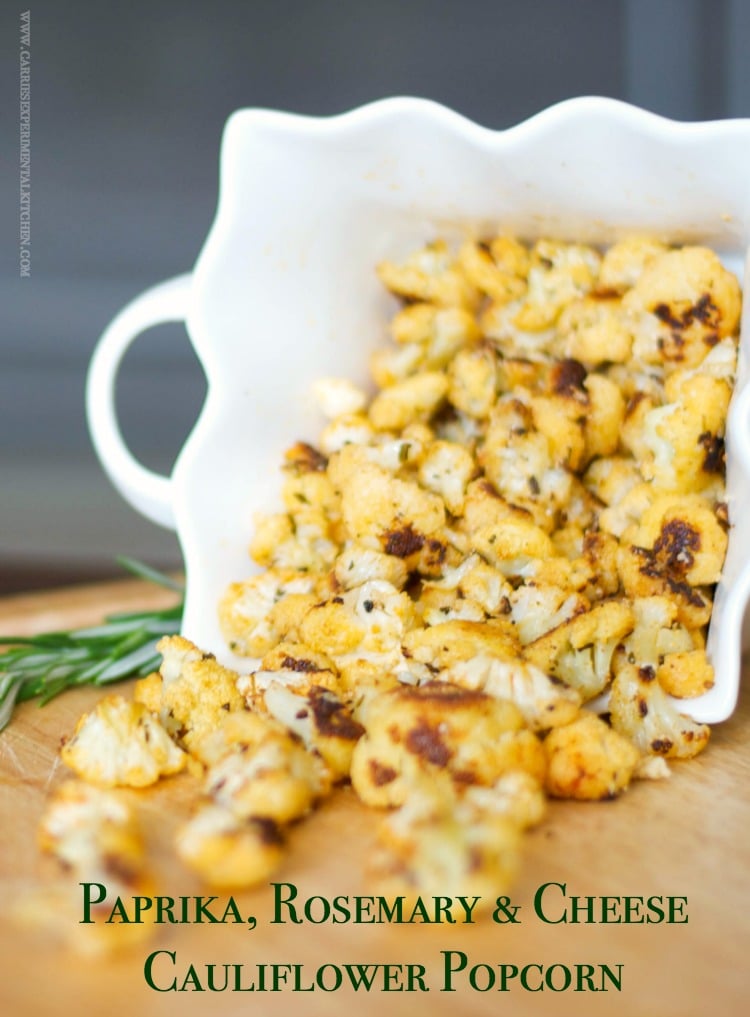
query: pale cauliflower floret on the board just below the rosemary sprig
[{"left": 60, "top": 695, "right": 185, "bottom": 787}]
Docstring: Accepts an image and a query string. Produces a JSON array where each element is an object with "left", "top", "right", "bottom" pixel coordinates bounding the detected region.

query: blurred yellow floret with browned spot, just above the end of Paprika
[{"left": 176, "top": 803, "right": 284, "bottom": 889}]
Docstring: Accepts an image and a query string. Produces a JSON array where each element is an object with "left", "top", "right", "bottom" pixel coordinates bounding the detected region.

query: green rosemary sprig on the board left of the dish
[{"left": 0, "top": 557, "right": 184, "bottom": 731}]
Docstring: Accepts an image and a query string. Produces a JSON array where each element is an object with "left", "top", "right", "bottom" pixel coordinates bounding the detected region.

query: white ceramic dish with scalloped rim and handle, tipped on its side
[{"left": 88, "top": 98, "right": 750, "bottom": 722}]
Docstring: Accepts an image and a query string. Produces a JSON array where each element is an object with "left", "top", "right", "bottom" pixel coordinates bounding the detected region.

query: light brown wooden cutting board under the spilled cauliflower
[{"left": 0, "top": 582, "right": 750, "bottom": 1017}]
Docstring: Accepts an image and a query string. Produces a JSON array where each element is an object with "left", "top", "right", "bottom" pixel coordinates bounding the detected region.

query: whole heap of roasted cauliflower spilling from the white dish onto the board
[{"left": 45, "top": 236, "right": 741, "bottom": 931}]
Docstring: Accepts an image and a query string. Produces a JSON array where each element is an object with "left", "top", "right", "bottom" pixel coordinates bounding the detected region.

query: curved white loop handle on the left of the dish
[{"left": 85, "top": 274, "right": 192, "bottom": 530}]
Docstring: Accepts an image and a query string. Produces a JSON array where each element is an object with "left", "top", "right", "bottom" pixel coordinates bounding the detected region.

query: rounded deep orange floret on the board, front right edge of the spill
[{"left": 544, "top": 712, "right": 640, "bottom": 800}]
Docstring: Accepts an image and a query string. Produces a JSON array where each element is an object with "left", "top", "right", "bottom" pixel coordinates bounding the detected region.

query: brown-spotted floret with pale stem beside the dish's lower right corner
[{"left": 610, "top": 664, "right": 710, "bottom": 759}]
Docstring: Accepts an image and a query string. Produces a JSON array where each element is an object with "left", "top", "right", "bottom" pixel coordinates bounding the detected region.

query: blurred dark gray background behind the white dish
[{"left": 0, "top": 0, "right": 750, "bottom": 592}]
